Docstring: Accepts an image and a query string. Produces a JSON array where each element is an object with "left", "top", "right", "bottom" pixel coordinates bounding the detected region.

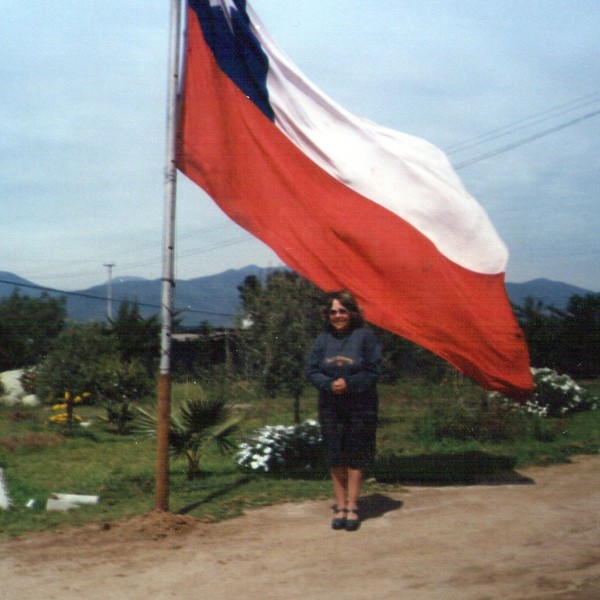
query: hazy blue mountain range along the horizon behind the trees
[{"left": 0, "top": 265, "right": 595, "bottom": 327}]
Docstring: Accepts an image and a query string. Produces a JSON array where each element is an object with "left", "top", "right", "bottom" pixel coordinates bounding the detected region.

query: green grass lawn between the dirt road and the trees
[{"left": 0, "top": 380, "right": 600, "bottom": 536}]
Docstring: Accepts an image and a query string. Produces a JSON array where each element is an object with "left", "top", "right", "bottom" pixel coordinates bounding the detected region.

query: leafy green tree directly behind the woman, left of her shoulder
[{"left": 238, "top": 270, "right": 323, "bottom": 423}]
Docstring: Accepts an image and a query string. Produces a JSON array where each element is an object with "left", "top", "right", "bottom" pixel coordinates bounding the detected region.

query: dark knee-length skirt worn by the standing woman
[{"left": 319, "top": 396, "right": 378, "bottom": 469}]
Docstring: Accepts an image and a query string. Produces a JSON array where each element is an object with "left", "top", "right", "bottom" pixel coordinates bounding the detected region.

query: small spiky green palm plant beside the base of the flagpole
[{"left": 136, "top": 395, "right": 241, "bottom": 480}]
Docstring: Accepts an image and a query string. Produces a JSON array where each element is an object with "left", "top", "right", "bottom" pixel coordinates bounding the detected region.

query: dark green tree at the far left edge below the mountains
[{"left": 0, "top": 289, "right": 66, "bottom": 370}]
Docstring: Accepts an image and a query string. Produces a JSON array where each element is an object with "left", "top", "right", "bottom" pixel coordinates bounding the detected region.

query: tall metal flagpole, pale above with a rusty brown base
[{"left": 155, "top": 0, "right": 181, "bottom": 511}]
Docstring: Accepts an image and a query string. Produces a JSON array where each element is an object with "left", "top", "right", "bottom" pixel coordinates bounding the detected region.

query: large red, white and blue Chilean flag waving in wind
[{"left": 177, "top": 0, "right": 534, "bottom": 397}]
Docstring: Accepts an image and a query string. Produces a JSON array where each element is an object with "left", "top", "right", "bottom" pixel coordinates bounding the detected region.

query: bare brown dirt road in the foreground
[{"left": 0, "top": 456, "right": 600, "bottom": 600}]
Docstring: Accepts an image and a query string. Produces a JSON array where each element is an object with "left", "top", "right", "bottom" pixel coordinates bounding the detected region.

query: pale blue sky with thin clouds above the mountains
[{"left": 0, "top": 0, "right": 600, "bottom": 292}]
